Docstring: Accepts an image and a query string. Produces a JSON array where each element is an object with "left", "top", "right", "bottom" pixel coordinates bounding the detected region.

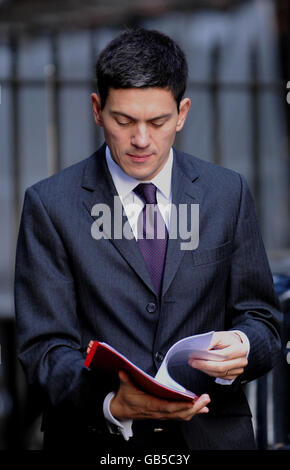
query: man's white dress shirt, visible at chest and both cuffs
[{"left": 103, "top": 146, "right": 250, "bottom": 440}]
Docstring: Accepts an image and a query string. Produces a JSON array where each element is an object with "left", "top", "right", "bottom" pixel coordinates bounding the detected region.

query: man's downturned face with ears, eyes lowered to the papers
[{"left": 92, "top": 88, "right": 190, "bottom": 181}]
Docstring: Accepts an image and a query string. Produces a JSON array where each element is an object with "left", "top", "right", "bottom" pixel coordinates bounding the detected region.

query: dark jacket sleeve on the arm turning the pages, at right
[{"left": 227, "top": 173, "right": 281, "bottom": 381}]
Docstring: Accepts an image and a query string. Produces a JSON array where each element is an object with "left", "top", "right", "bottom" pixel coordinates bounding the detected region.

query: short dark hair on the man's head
[{"left": 96, "top": 28, "right": 188, "bottom": 109}]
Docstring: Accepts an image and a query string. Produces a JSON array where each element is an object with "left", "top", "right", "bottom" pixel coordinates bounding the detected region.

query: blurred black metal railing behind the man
[{"left": 0, "top": 31, "right": 290, "bottom": 448}]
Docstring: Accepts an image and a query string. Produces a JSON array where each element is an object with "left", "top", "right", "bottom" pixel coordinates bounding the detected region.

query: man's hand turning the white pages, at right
[{"left": 189, "top": 331, "right": 248, "bottom": 380}]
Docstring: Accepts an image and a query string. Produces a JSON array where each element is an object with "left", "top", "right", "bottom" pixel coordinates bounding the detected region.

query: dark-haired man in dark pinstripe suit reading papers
[{"left": 15, "top": 29, "right": 280, "bottom": 453}]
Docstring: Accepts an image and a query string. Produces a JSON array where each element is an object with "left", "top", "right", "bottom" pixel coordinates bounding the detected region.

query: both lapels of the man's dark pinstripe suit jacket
[{"left": 82, "top": 144, "right": 200, "bottom": 302}]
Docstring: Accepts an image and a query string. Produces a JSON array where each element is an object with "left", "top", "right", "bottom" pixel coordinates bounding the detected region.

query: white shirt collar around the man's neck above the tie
[{"left": 106, "top": 146, "right": 173, "bottom": 200}]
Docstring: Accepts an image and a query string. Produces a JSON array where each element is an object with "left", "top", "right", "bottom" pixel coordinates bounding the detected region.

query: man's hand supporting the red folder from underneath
[{"left": 110, "top": 371, "right": 210, "bottom": 421}]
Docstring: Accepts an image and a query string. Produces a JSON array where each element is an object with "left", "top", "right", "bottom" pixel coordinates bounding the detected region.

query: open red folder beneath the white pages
[{"left": 84, "top": 341, "right": 198, "bottom": 402}]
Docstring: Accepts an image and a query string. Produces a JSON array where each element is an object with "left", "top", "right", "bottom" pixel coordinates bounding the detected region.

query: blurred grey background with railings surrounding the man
[{"left": 0, "top": 0, "right": 290, "bottom": 449}]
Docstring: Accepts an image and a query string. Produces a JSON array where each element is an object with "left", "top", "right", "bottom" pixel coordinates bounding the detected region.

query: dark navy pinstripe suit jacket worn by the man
[{"left": 15, "top": 146, "right": 280, "bottom": 449}]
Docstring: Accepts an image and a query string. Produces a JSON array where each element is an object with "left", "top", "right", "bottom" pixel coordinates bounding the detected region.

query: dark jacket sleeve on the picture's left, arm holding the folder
[{"left": 15, "top": 187, "right": 112, "bottom": 421}]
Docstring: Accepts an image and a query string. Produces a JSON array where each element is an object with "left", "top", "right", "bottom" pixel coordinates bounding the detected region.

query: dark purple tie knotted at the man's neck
[{"left": 134, "top": 183, "right": 168, "bottom": 295}]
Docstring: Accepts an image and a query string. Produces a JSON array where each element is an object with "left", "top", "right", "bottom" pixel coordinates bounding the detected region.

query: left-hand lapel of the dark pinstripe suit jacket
[{"left": 82, "top": 145, "right": 155, "bottom": 294}]
